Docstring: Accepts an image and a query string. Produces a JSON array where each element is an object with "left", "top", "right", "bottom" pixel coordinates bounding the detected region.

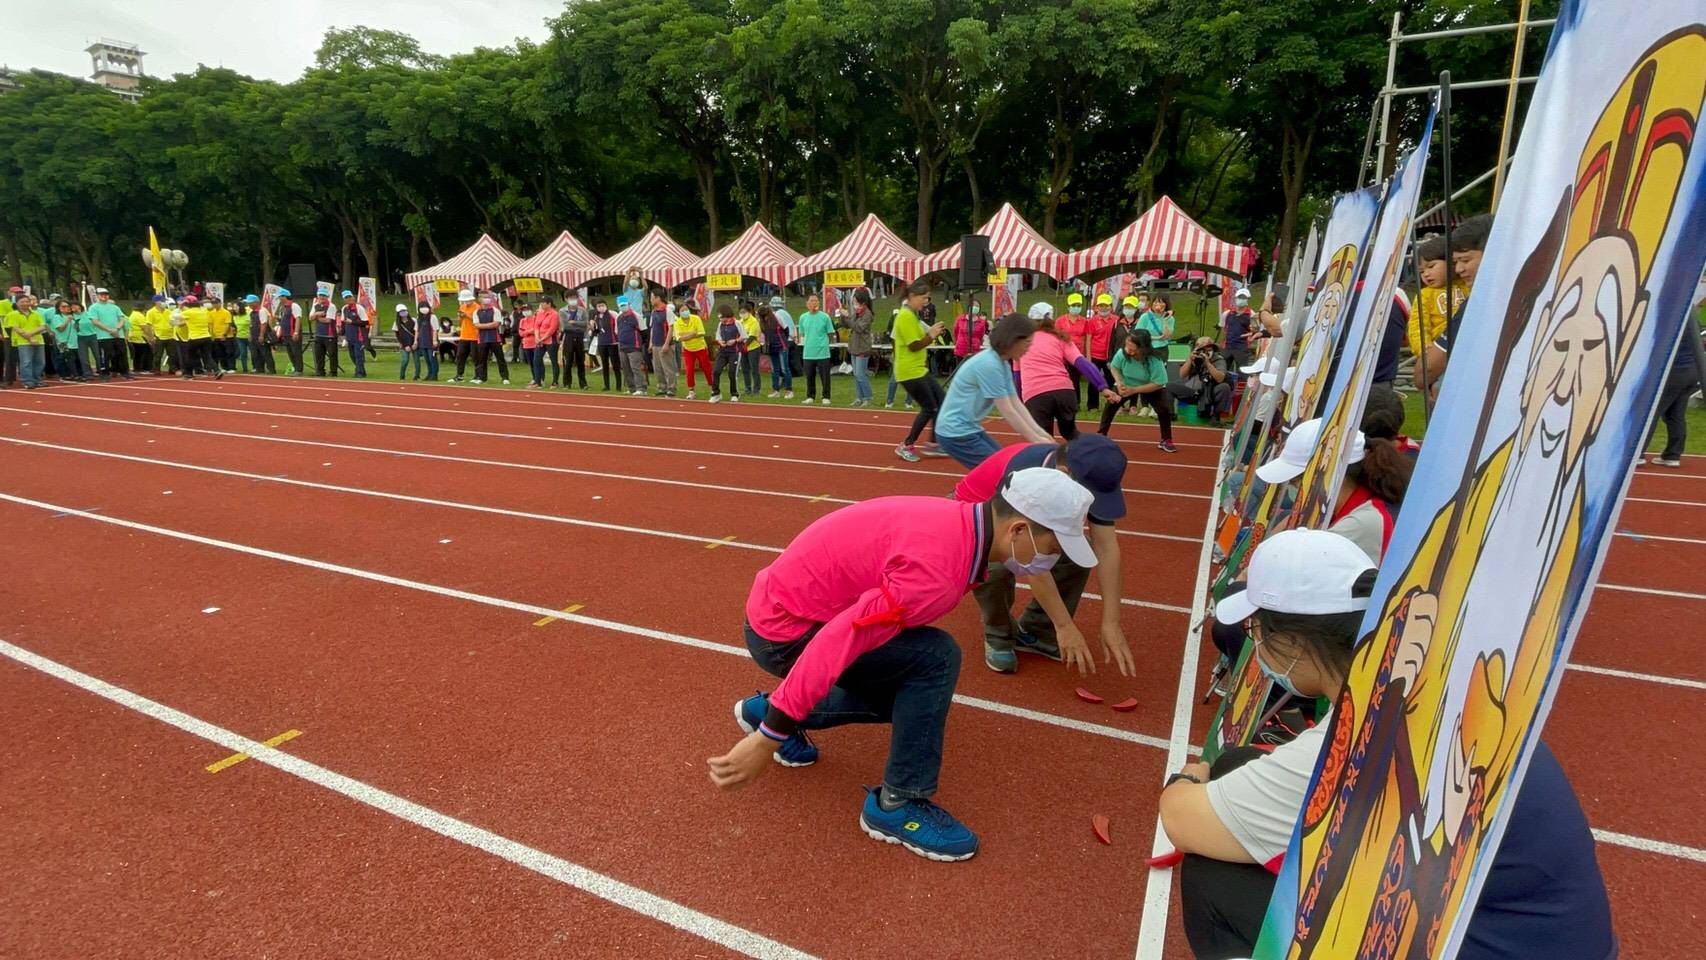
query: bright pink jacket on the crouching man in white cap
[{"left": 746, "top": 496, "right": 989, "bottom": 735}]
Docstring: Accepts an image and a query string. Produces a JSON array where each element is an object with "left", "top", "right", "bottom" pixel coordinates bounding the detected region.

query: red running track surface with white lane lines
[{"left": 0, "top": 379, "right": 1706, "bottom": 958}]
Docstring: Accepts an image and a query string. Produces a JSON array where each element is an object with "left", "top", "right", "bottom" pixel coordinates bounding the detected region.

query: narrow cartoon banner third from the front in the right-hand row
[{"left": 1283, "top": 184, "right": 1384, "bottom": 426}]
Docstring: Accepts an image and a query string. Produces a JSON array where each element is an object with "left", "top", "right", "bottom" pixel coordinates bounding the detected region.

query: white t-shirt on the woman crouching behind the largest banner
[{"left": 1208, "top": 711, "right": 1332, "bottom": 865}]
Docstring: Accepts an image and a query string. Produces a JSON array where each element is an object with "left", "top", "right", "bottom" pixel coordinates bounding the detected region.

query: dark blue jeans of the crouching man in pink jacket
[{"left": 746, "top": 624, "right": 960, "bottom": 800}]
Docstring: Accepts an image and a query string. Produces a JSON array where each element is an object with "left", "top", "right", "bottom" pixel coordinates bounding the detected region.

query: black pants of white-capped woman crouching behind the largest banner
[{"left": 1179, "top": 747, "right": 1278, "bottom": 960}]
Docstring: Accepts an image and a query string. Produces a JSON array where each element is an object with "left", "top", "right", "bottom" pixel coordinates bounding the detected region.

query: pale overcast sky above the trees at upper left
[{"left": 0, "top": 0, "right": 565, "bottom": 80}]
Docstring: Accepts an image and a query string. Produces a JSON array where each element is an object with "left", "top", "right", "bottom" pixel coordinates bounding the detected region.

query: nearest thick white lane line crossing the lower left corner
[{"left": 0, "top": 639, "right": 812, "bottom": 960}]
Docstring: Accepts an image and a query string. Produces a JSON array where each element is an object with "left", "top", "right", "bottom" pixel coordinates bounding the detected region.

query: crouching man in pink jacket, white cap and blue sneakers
[{"left": 708, "top": 467, "right": 1095, "bottom": 859}]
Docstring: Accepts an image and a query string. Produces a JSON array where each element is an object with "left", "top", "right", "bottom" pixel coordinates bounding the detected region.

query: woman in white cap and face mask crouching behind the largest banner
[{"left": 1160, "top": 530, "right": 1617, "bottom": 960}]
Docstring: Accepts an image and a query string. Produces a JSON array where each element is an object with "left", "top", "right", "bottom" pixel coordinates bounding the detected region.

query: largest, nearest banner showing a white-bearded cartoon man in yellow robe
[{"left": 1256, "top": 0, "right": 1706, "bottom": 960}]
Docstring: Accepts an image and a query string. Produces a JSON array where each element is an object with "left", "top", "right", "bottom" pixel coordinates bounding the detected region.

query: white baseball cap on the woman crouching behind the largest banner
[{"left": 1215, "top": 530, "right": 1375, "bottom": 624}]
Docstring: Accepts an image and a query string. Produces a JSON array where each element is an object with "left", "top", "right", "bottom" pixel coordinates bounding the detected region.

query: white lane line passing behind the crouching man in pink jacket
[{"left": 0, "top": 491, "right": 1173, "bottom": 752}]
